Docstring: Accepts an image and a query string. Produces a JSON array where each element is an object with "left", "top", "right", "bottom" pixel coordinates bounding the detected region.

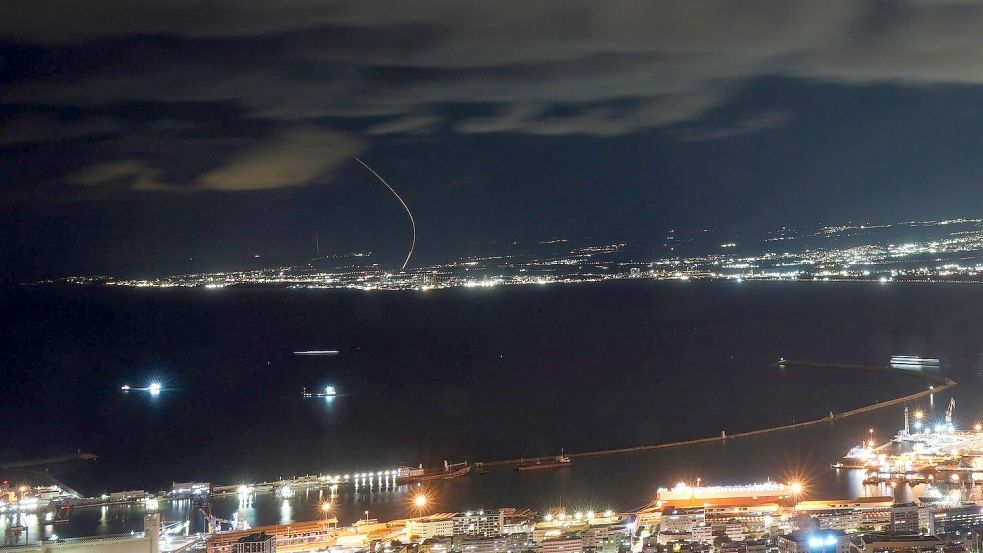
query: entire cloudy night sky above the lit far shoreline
[{"left": 0, "top": 0, "right": 983, "bottom": 279}]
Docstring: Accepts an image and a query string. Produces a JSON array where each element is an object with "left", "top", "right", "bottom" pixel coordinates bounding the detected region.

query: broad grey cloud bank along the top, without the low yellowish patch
[{"left": 0, "top": 0, "right": 983, "bottom": 149}]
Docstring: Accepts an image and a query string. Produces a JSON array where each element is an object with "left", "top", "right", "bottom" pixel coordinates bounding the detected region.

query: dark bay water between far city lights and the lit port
[{"left": 0, "top": 281, "right": 983, "bottom": 535}]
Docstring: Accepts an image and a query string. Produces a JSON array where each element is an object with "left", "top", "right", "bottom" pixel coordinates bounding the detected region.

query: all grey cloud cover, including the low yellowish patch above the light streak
[{"left": 0, "top": 0, "right": 983, "bottom": 197}]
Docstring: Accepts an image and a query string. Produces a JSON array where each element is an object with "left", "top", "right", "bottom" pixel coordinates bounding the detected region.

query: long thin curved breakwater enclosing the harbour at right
[{"left": 481, "top": 359, "right": 956, "bottom": 467}]
